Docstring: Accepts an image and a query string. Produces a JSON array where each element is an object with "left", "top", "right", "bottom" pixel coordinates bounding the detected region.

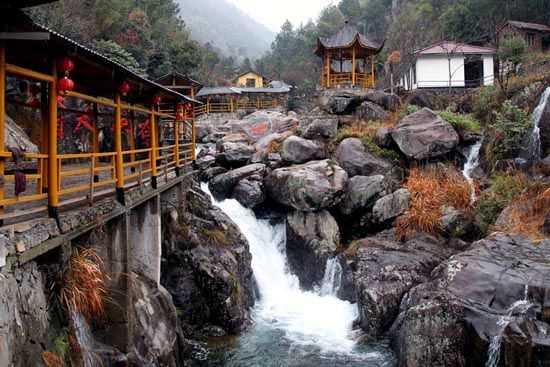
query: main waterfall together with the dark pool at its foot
[{"left": 199, "top": 184, "right": 395, "bottom": 367}]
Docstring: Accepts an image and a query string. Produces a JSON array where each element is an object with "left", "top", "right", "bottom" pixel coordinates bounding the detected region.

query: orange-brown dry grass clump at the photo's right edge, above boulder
[{"left": 495, "top": 183, "right": 550, "bottom": 240}]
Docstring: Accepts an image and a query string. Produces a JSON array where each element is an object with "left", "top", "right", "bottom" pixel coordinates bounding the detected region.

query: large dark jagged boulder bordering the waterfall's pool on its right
[{"left": 341, "top": 236, "right": 464, "bottom": 340}]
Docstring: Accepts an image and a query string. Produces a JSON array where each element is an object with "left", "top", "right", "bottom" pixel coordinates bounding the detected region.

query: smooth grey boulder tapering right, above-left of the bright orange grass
[{"left": 336, "top": 138, "right": 394, "bottom": 177}]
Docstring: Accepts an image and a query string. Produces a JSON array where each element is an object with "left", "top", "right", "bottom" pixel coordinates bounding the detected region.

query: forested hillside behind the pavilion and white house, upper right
[{"left": 257, "top": 0, "right": 550, "bottom": 86}]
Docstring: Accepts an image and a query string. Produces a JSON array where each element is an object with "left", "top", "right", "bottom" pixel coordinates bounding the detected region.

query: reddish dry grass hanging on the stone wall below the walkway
[{"left": 59, "top": 247, "right": 108, "bottom": 322}]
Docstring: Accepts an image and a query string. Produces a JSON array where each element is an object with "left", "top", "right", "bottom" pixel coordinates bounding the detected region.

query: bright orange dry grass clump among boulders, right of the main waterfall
[{"left": 396, "top": 167, "right": 470, "bottom": 239}]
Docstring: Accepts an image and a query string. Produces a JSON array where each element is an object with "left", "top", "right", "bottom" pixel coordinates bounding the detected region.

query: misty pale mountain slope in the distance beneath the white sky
[{"left": 176, "top": 0, "right": 275, "bottom": 59}]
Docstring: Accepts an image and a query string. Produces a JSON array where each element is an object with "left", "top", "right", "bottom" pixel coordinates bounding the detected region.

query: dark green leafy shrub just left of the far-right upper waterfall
[{"left": 489, "top": 101, "right": 533, "bottom": 163}]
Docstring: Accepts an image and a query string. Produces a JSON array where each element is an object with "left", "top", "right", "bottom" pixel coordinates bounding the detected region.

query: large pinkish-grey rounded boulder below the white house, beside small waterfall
[{"left": 392, "top": 108, "right": 459, "bottom": 160}]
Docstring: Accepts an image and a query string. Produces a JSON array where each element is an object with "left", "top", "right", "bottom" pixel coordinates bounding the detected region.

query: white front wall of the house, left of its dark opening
[{"left": 414, "top": 54, "right": 465, "bottom": 88}]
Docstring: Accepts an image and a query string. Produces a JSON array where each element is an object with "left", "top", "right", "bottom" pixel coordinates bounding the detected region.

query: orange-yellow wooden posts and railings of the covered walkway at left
[{"left": 0, "top": 46, "right": 195, "bottom": 221}]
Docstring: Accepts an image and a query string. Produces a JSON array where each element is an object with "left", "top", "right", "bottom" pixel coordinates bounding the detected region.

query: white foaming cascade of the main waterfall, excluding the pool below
[{"left": 201, "top": 183, "right": 364, "bottom": 358}]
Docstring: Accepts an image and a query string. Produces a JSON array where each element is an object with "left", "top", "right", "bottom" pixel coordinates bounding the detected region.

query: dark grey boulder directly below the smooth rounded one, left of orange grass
[{"left": 339, "top": 175, "right": 385, "bottom": 214}]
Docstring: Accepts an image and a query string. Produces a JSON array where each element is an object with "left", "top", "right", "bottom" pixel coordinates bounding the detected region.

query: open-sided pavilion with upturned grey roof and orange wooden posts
[{"left": 315, "top": 21, "right": 384, "bottom": 89}]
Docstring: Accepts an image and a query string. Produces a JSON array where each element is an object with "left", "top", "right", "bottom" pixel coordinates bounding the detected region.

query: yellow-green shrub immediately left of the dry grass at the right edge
[{"left": 475, "top": 172, "right": 528, "bottom": 232}]
